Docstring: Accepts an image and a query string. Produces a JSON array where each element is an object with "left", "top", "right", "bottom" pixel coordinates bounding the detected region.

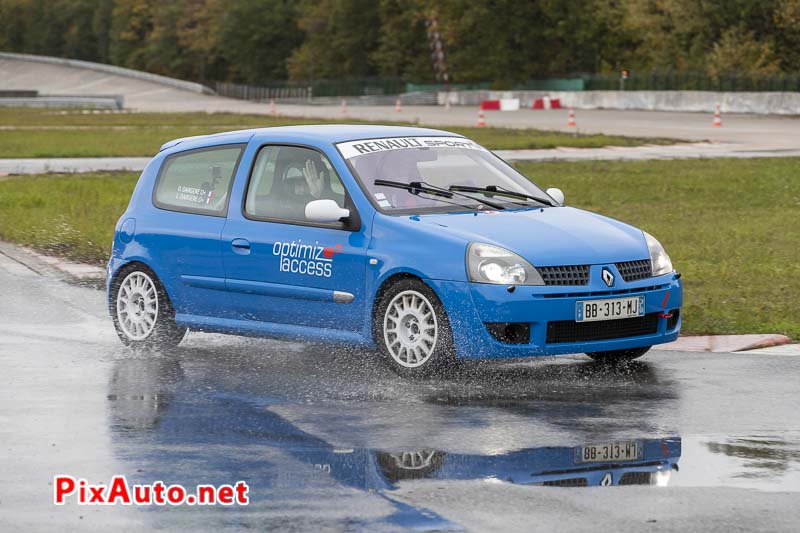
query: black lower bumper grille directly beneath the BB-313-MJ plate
[{"left": 547, "top": 313, "right": 658, "bottom": 344}]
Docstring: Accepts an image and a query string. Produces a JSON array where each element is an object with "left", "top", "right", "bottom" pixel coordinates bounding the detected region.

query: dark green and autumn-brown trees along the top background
[{"left": 0, "top": 0, "right": 800, "bottom": 88}]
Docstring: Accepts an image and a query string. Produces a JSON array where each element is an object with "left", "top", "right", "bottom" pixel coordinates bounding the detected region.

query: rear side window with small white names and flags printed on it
[{"left": 153, "top": 144, "right": 244, "bottom": 216}]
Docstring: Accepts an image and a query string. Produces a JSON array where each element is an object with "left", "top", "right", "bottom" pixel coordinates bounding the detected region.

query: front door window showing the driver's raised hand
[{"left": 245, "top": 146, "right": 345, "bottom": 222}]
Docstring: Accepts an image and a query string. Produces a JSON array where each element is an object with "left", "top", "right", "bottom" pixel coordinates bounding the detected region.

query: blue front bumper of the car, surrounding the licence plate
[{"left": 427, "top": 273, "right": 683, "bottom": 359}]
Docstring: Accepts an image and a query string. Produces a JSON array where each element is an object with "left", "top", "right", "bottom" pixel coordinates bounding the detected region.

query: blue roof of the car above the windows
[{"left": 161, "top": 124, "right": 461, "bottom": 150}]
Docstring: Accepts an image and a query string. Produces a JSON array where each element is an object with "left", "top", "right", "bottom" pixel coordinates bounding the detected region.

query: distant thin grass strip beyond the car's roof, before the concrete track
[{"left": 0, "top": 108, "right": 676, "bottom": 158}]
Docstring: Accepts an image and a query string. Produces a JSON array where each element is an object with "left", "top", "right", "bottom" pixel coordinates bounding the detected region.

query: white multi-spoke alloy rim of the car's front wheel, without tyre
[{"left": 383, "top": 290, "right": 439, "bottom": 368}]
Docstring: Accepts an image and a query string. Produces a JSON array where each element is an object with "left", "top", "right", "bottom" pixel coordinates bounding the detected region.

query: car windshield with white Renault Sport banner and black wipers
[{"left": 336, "top": 137, "right": 552, "bottom": 213}]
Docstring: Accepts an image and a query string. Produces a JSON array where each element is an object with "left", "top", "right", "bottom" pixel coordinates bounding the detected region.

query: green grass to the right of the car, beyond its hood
[{"left": 520, "top": 159, "right": 800, "bottom": 340}]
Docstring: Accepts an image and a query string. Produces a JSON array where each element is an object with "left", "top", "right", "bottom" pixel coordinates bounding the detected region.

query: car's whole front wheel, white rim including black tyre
[{"left": 373, "top": 279, "right": 457, "bottom": 377}]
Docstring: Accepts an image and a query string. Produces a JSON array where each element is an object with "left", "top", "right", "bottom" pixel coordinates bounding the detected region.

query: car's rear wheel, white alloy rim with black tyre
[{"left": 111, "top": 264, "right": 186, "bottom": 347}]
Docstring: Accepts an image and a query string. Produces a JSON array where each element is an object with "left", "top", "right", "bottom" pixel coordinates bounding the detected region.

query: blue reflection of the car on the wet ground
[{"left": 108, "top": 344, "right": 681, "bottom": 528}]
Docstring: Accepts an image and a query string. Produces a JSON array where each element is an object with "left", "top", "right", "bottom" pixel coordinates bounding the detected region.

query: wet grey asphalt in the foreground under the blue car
[{"left": 0, "top": 250, "right": 800, "bottom": 531}]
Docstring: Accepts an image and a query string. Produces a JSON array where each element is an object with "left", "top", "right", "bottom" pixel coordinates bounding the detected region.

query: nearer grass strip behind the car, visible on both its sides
[{"left": 0, "top": 159, "right": 800, "bottom": 340}]
